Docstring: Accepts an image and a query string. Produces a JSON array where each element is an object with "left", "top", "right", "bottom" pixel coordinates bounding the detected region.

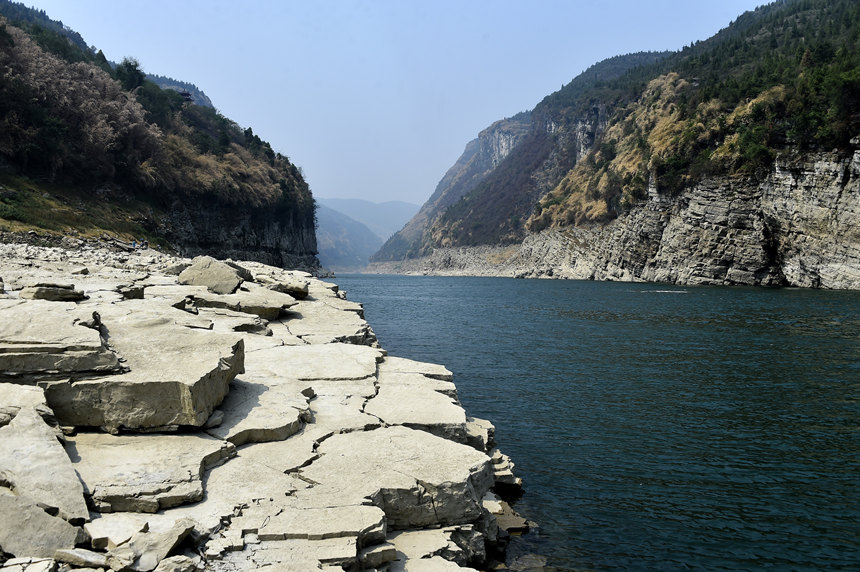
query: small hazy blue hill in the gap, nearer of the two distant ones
[{"left": 317, "top": 204, "right": 382, "bottom": 272}]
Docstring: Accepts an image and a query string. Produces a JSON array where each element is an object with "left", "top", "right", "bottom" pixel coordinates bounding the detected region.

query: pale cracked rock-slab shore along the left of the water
[{"left": 0, "top": 243, "right": 526, "bottom": 572}]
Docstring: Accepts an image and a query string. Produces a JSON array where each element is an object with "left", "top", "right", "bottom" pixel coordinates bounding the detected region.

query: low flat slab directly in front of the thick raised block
[{"left": 66, "top": 433, "right": 235, "bottom": 512}]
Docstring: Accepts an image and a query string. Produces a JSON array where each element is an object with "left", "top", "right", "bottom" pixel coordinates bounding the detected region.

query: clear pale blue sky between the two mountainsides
[{"left": 21, "top": 0, "right": 765, "bottom": 204}]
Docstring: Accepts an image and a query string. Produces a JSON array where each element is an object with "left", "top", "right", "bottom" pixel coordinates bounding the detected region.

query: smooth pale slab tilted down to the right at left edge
[{"left": 0, "top": 408, "right": 89, "bottom": 524}]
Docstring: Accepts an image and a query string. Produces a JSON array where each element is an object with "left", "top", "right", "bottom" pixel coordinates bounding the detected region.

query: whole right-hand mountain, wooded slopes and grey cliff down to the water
[{"left": 373, "top": 0, "right": 860, "bottom": 287}]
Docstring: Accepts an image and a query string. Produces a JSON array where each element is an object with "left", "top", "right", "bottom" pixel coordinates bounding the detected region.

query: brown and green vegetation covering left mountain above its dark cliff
[{"left": 0, "top": 2, "right": 314, "bottom": 246}]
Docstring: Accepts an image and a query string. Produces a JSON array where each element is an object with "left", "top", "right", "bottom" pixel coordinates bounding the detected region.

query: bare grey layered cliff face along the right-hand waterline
[{"left": 370, "top": 147, "right": 860, "bottom": 289}]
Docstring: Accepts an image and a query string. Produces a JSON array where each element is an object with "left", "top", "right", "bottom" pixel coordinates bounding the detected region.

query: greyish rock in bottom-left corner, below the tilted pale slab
[{"left": 0, "top": 488, "right": 83, "bottom": 558}]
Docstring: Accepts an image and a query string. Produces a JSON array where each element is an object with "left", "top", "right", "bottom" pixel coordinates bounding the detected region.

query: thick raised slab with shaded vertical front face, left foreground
[{"left": 46, "top": 300, "right": 244, "bottom": 431}]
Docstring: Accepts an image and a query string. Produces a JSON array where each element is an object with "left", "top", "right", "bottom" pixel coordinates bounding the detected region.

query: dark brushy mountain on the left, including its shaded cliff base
[{"left": 0, "top": 0, "right": 318, "bottom": 268}]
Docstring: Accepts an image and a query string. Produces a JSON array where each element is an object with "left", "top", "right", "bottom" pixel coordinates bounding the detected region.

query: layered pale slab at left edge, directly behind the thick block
[{"left": 0, "top": 299, "right": 122, "bottom": 383}]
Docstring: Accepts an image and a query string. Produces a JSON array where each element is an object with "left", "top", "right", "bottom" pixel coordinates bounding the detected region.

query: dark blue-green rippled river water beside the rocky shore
[{"left": 336, "top": 275, "right": 860, "bottom": 570}]
